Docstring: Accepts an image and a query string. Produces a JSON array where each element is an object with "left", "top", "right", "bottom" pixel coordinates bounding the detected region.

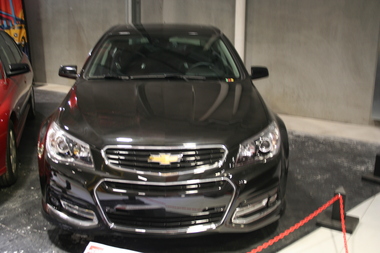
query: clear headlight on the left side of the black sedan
[{"left": 46, "top": 122, "right": 93, "bottom": 167}]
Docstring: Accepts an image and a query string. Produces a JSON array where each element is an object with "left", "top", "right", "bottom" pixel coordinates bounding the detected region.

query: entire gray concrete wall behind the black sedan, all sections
[{"left": 25, "top": 0, "right": 380, "bottom": 124}]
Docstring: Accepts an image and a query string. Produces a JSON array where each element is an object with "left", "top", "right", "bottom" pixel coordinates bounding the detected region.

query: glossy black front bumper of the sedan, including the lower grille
[{"left": 40, "top": 155, "right": 283, "bottom": 236}]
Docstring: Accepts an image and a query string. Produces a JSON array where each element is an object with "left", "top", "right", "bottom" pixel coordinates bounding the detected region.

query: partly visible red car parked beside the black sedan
[{"left": 0, "top": 31, "right": 34, "bottom": 186}]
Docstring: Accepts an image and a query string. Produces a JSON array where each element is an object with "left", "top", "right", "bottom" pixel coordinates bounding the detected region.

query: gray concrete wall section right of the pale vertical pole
[{"left": 246, "top": 0, "right": 380, "bottom": 124}]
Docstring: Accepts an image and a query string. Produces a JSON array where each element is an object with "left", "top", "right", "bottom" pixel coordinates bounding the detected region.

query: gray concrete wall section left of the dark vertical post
[{"left": 24, "top": 0, "right": 126, "bottom": 85}]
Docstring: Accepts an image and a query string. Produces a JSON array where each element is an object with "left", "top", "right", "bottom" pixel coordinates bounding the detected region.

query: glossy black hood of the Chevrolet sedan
[{"left": 59, "top": 80, "right": 269, "bottom": 149}]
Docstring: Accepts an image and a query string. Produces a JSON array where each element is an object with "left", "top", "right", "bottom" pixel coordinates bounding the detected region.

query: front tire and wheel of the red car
[{"left": 0, "top": 121, "right": 18, "bottom": 186}]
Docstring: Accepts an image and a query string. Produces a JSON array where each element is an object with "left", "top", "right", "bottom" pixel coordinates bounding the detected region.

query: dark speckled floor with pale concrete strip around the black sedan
[{"left": 0, "top": 85, "right": 380, "bottom": 253}]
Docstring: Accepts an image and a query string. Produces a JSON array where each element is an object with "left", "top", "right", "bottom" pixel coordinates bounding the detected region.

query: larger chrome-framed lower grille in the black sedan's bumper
[{"left": 95, "top": 179, "right": 235, "bottom": 233}]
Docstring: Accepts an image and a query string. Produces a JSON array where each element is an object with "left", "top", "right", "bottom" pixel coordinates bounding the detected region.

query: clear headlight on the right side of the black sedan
[{"left": 236, "top": 122, "right": 281, "bottom": 166}]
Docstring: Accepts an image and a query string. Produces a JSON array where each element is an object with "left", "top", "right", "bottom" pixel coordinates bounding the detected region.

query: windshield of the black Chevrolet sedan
[{"left": 85, "top": 35, "right": 240, "bottom": 80}]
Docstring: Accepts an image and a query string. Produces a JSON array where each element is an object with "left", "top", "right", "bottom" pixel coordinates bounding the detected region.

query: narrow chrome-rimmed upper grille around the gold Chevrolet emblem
[{"left": 103, "top": 146, "right": 227, "bottom": 171}]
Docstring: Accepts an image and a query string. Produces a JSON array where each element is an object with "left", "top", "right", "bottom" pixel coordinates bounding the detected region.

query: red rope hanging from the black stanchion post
[{"left": 248, "top": 194, "right": 348, "bottom": 253}]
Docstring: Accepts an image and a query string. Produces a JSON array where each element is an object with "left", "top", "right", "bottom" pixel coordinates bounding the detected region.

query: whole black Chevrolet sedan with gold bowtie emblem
[{"left": 38, "top": 25, "right": 289, "bottom": 236}]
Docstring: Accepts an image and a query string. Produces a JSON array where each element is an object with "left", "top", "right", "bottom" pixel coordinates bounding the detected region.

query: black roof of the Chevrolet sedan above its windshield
[{"left": 106, "top": 24, "right": 222, "bottom": 36}]
